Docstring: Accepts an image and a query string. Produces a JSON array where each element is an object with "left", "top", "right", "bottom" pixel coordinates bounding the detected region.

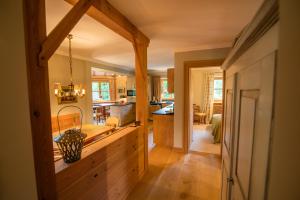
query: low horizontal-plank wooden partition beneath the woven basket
[{"left": 55, "top": 127, "right": 145, "bottom": 200}]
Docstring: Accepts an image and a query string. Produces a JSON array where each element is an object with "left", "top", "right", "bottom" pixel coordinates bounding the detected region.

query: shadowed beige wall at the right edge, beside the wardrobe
[{"left": 268, "top": 0, "right": 300, "bottom": 200}]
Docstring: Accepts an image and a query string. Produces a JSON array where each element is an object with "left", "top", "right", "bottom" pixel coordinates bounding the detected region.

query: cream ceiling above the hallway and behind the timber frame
[{"left": 46, "top": 0, "right": 263, "bottom": 70}]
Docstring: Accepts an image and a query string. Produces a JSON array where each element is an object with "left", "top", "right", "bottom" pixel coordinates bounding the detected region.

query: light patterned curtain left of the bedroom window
[{"left": 204, "top": 72, "right": 214, "bottom": 123}]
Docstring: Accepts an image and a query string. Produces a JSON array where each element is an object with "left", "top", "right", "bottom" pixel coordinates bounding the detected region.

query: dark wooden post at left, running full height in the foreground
[{"left": 23, "top": 0, "right": 56, "bottom": 200}]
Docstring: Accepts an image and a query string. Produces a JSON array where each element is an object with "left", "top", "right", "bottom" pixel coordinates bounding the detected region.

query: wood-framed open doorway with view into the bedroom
[{"left": 183, "top": 60, "right": 224, "bottom": 156}]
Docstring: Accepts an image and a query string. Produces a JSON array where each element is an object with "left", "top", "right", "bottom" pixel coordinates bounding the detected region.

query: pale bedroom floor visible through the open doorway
[{"left": 190, "top": 124, "right": 221, "bottom": 155}]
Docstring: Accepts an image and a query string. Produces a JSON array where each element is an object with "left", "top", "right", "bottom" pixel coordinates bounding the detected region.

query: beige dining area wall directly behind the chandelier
[{"left": 48, "top": 54, "right": 92, "bottom": 123}]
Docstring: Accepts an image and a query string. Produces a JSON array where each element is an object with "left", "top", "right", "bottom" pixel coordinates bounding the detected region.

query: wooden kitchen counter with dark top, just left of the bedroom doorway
[{"left": 152, "top": 104, "right": 174, "bottom": 148}]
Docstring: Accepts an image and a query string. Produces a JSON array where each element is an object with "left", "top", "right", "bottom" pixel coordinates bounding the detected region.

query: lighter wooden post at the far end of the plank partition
[{"left": 133, "top": 40, "right": 149, "bottom": 172}]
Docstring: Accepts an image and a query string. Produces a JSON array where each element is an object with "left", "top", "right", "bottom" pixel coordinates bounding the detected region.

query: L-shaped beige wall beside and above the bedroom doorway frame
[{"left": 174, "top": 48, "right": 229, "bottom": 148}]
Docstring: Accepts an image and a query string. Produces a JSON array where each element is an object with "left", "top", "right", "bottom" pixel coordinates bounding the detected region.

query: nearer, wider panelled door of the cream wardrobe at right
[{"left": 231, "top": 53, "right": 275, "bottom": 200}]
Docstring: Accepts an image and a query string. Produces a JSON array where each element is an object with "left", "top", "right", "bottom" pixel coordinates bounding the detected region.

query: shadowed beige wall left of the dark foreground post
[{"left": 0, "top": 0, "right": 37, "bottom": 200}]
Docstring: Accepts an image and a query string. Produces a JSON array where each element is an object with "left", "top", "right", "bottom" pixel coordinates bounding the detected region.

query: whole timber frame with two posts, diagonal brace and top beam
[{"left": 23, "top": 0, "right": 150, "bottom": 200}]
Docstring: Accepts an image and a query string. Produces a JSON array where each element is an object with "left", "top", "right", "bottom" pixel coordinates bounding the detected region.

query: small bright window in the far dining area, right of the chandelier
[{"left": 92, "top": 82, "right": 111, "bottom": 101}]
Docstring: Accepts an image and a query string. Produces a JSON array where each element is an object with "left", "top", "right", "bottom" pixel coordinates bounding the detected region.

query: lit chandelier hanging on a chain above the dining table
[{"left": 54, "top": 34, "right": 85, "bottom": 104}]
